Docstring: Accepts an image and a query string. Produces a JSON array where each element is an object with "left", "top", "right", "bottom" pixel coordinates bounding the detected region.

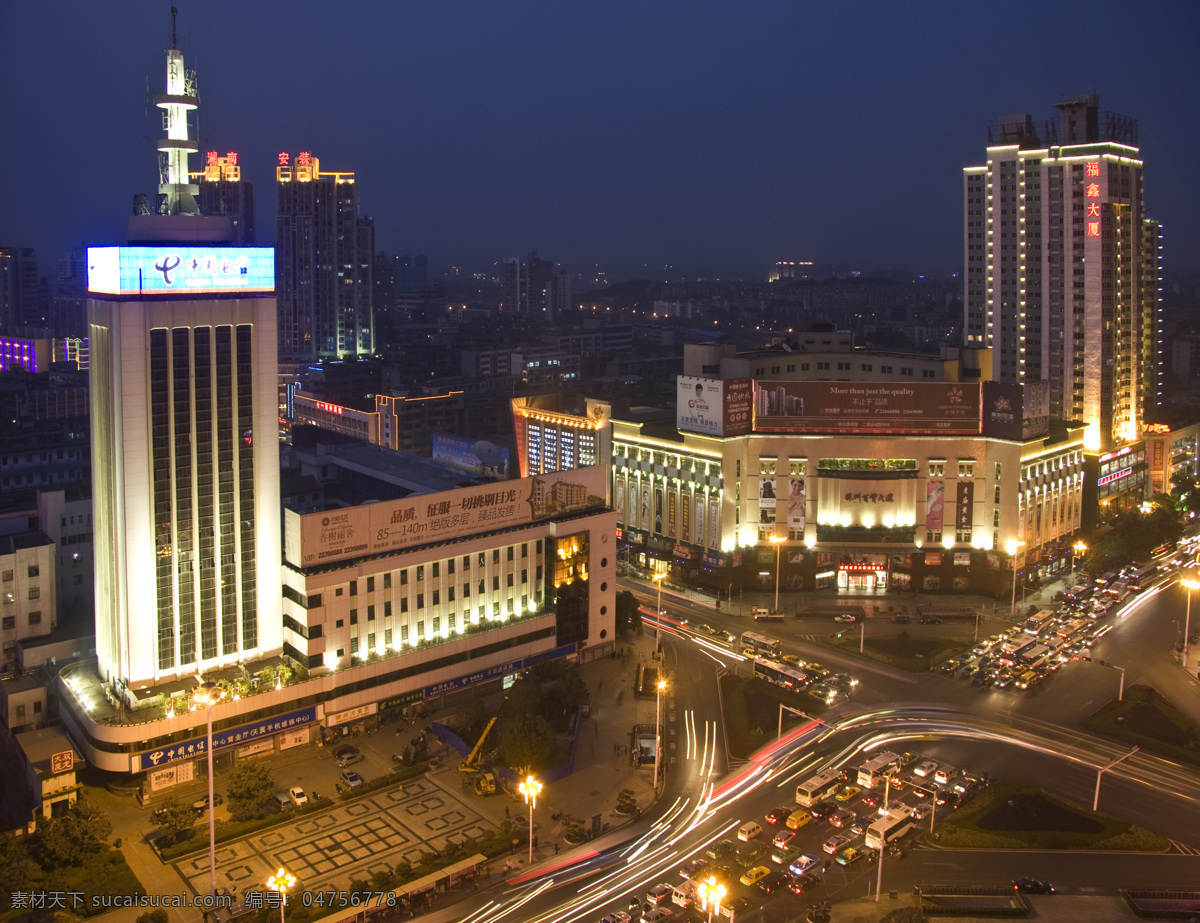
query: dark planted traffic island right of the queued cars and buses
[{"left": 931, "top": 781, "right": 1170, "bottom": 852}]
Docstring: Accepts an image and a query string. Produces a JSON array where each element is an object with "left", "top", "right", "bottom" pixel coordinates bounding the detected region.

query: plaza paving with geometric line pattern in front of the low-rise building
[{"left": 174, "top": 778, "right": 497, "bottom": 893}]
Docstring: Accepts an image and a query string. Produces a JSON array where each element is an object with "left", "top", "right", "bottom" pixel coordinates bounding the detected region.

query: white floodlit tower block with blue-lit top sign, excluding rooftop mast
[{"left": 88, "top": 242, "right": 282, "bottom": 689}]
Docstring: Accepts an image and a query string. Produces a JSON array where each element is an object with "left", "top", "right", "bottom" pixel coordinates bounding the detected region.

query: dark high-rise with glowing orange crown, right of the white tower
[{"left": 275, "top": 151, "right": 374, "bottom": 361}]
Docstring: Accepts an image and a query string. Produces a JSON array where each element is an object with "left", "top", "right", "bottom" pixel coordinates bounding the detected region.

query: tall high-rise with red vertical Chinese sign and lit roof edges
[{"left": 964, "top": 95, "right": 1162, "bottom": 451}]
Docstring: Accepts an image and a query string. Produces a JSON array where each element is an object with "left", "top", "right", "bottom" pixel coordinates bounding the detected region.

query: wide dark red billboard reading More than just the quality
[{"left": 754, "top": 382, "right": 982, "bottom": 434}]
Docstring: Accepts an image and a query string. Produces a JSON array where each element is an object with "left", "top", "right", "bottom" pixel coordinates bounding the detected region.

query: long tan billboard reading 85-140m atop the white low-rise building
[{"left": 284, "top": 466, "right": 606, "bottom": 567}]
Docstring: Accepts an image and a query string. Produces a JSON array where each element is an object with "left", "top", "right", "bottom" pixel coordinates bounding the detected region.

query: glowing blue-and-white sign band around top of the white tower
[{"left": 88, "top": 244, "right": 275, "bottom": 298}]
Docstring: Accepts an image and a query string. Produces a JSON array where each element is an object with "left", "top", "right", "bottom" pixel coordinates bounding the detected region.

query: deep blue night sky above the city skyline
[{"left": 0, "top": 0, "right": 1200, "bottom": 278}]
